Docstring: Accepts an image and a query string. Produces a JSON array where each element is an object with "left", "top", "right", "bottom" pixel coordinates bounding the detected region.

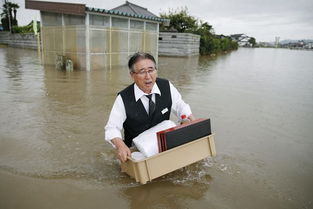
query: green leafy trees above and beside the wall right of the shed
[{"left": 160, "top": 7, "right": 238, "bottom": 55}]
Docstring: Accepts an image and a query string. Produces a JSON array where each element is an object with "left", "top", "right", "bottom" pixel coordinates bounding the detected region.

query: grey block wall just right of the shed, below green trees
[{"left": 159, "top": 32, "right": 200, "bottom": 56}]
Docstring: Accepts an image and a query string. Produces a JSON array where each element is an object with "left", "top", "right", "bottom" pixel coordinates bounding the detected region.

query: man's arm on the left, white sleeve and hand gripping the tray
[{"left": 104, "top": 95, "right": 130, "bottom": 162}]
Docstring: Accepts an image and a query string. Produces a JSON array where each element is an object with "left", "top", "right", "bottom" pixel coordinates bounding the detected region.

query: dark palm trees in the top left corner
[{"left": 1, "top": 0, "right": 20, "bottom": 31}]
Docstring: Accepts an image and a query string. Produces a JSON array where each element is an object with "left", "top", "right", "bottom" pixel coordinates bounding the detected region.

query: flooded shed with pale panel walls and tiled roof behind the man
[{"left": 25, "top": 0, "right": 168, "bottom": 70}]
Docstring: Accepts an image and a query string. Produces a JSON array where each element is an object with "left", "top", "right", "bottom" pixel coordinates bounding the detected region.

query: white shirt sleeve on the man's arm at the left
[{"left": 104, "top": 95, "right": 126, "bottom": 146}]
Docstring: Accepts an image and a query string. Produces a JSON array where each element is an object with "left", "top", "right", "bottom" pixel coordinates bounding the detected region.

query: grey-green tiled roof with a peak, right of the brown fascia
[{"left": 86, "top": 1, "right": 167, "bottom": 22}]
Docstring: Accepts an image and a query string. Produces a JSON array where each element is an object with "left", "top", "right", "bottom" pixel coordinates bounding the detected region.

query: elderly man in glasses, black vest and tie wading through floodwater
[{"left": 105, "top": 53, "right": 195, "bottom": 162}]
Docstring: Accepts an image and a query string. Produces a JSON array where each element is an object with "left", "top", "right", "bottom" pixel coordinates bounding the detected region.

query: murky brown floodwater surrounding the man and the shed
[{"left": 0, "top": 47, "right": 313, "bottom": 209}]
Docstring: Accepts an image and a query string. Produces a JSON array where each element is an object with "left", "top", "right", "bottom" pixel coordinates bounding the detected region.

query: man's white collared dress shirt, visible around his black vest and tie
[{"left": 104, "top": 82, "right": 192, "bottom": 144}]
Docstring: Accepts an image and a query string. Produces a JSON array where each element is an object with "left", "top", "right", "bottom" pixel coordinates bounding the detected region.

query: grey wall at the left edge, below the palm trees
[{"left": 0, "top": 32, "right": 37, "bottom": 49}]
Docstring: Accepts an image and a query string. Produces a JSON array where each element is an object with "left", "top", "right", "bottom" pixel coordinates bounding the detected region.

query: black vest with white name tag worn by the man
[{"left": 119, "top": 78, "right": 172, "bottom": 147}]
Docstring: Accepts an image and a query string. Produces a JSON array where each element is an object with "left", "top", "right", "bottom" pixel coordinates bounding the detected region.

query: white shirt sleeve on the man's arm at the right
[{"left": 170, "top": 82, "right": 192, "bottom": 119}]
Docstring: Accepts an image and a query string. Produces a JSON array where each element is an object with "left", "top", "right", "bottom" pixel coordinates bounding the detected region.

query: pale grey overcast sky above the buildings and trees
[{"left": 4, "top": 0, "right": 313, "bottom": 41}]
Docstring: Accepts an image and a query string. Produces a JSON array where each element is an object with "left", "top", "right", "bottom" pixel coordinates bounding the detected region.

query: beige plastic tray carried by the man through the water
[{"left": 121, "top": 134, "right": 216, "bottom": 184}]
